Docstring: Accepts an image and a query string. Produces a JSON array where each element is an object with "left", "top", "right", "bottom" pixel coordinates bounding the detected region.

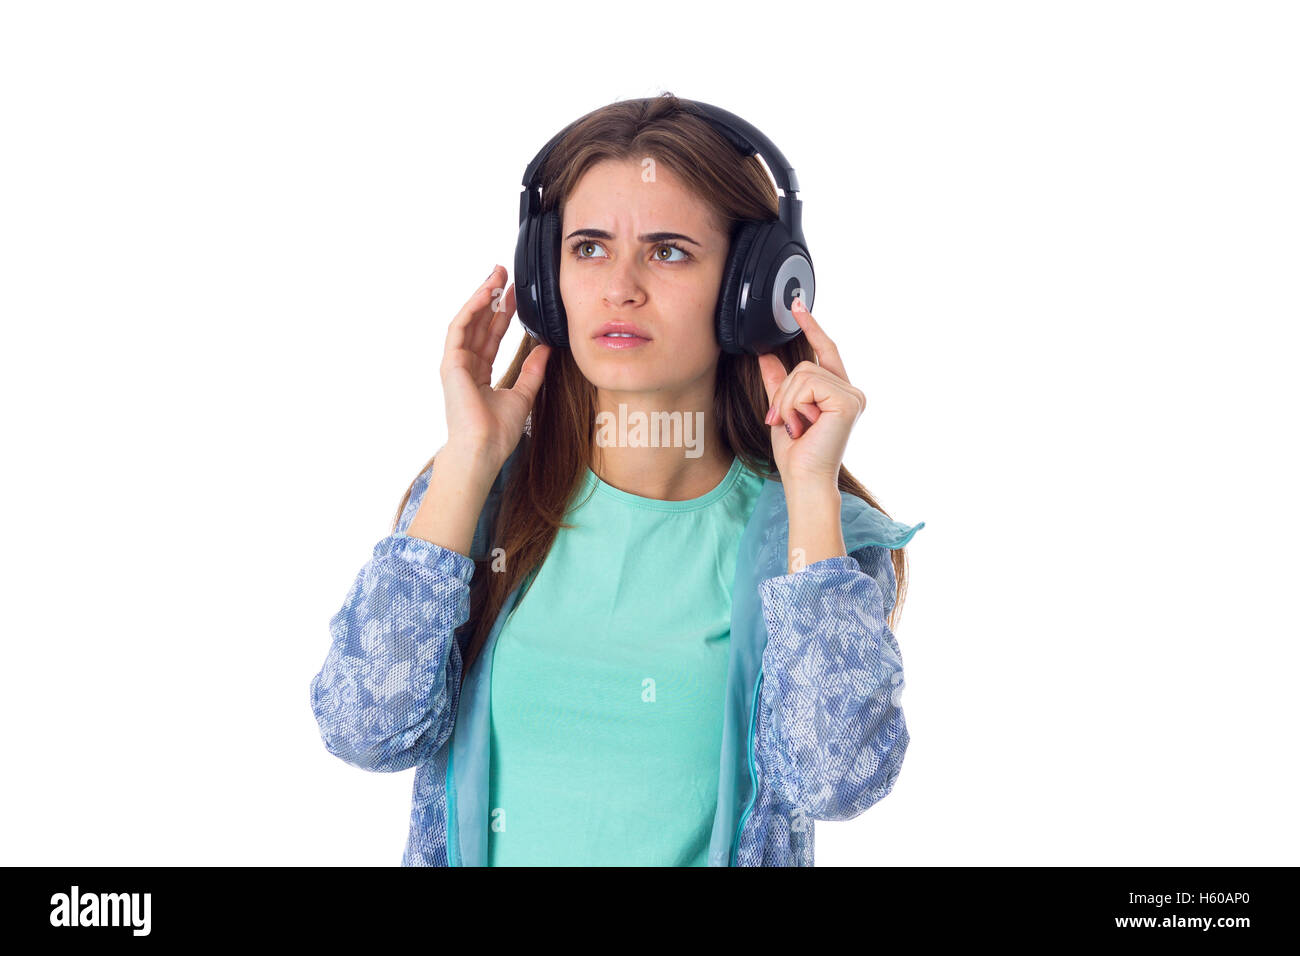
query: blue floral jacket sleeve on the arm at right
[{"left": 759, "top": 545, "right": 909, "bottom": 821}]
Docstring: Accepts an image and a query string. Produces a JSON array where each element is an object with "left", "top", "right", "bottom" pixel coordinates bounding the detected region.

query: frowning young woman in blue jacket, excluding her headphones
[{"left": 311, "top": 94, "right": 923, "bottom": 866}]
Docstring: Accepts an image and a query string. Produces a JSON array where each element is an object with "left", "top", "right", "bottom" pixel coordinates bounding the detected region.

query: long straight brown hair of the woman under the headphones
[{"left": 393, "top": 92, "right": 907, "bottom": 680}]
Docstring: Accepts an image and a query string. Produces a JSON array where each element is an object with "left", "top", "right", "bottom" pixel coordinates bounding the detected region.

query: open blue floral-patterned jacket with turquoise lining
[{"left": 311, "top": 447, "right": 924, "bottom": 866}]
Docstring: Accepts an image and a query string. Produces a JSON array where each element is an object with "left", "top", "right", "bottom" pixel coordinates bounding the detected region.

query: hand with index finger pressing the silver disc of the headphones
[{"left": 758, "top": 298, "right": 867, "bottom": 485}]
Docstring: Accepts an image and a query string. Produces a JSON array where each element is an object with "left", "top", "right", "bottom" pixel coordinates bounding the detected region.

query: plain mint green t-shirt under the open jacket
[{"left": 488, "top": 458, "right": 763, "bottom": 866}]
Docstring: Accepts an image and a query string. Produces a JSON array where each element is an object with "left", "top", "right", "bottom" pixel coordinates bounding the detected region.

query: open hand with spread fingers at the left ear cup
[{"left": 439, "top": 265, "right": 551, "bottom": 473}]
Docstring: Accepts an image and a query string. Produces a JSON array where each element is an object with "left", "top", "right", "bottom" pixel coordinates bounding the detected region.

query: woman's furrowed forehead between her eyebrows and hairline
[{"left": 563, "top": 160, "right": 715, "bottom": 233}]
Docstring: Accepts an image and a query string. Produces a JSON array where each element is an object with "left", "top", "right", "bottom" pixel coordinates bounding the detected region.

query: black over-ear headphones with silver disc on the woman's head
[{"left": 515, "top": 98, "right": 815, "bottom": 355}]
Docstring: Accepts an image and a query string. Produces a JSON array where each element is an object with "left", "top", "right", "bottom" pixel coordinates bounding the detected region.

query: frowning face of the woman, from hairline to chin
[{"left": 560, "top": 160, "right": 728, "bottom": 402}]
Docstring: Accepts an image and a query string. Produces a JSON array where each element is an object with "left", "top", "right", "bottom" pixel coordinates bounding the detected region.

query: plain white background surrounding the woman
[{"left": 0, "top": 0, "right": 1300, "bottom": 866}]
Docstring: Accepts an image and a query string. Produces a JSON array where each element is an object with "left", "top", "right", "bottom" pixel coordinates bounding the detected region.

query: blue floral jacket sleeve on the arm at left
[{"left": 311, "top": 466, "right": 475, "bottom": 773}]
